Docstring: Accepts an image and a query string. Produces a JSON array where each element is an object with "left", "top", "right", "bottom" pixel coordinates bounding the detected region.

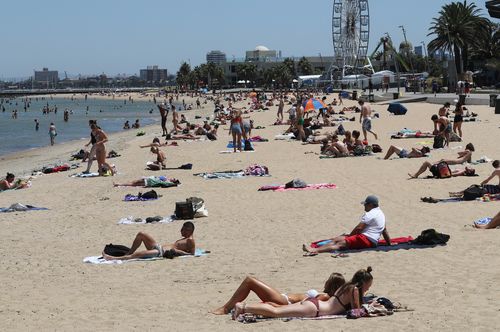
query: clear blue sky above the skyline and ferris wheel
[{"left": 0, "top": 0, "right": 488, "bottom": 79}]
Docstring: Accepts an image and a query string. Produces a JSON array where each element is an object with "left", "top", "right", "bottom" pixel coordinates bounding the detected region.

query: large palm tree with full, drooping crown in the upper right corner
[{"left": 427, "top": 0, "right": 489, "bottom": 75}]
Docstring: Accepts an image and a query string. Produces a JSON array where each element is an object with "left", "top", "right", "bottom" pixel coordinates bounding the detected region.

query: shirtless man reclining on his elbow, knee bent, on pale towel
[{"left": 102, "top": 221, "right": 196, "bottom": 260}]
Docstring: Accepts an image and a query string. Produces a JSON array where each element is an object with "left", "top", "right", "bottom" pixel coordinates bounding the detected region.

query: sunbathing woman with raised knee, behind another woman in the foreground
[{"left": 212, "top": 273, "right": 345, "bottom": 315}]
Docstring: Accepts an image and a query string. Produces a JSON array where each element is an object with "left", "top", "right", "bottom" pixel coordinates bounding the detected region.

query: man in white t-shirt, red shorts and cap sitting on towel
[{"left": 302, "top": 195, "right": 391, "bottom": 255}]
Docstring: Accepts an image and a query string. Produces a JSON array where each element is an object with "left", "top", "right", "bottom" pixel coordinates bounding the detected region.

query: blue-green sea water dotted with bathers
[{"left": 0, "top": 96, "right": 160, "bottom": 155}]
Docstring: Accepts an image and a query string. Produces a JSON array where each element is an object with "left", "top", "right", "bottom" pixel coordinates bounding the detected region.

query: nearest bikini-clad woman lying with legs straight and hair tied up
[{"left": 232, "top": 267, "right": 373, "bottom": 319}]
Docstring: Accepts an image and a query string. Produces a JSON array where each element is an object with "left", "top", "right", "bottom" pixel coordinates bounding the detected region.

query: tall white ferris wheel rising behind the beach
[{"left": 332, "top": 0, "right": 370, "bottom": 68}]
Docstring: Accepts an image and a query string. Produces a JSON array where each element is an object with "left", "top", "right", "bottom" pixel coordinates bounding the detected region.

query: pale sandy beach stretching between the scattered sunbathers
[{"left": 0, "top": 90, "right": 500, "bottom": 331}]
